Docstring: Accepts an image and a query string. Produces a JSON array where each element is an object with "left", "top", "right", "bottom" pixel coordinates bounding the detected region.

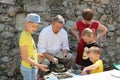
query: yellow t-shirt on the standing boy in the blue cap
[{"left": 19, "top": 31, "right": 38, "bottom": 68}]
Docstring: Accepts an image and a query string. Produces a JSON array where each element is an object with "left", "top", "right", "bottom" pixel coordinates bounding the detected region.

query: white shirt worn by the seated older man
[{"left": 37, "top": 25, "right": 69, "bottom": 56}]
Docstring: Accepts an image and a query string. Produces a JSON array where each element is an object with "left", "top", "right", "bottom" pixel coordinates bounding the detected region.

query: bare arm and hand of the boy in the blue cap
[{"left": 20, "top": 46, "right": 48, "bottom": 71}]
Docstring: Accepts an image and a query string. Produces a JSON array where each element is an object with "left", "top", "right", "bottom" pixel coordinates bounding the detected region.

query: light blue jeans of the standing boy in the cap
[{"left": 20, "top": 65, "right": 38, "bottom": 80}]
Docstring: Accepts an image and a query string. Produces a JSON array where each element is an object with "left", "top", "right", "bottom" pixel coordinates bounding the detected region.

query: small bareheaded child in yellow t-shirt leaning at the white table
[{"left": 81, "top": 46, "right": 103, "bottom": 74}]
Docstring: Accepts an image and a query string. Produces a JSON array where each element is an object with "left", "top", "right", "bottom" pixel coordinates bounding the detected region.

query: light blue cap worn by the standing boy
[{"left": 26, "top": 13, "right": 41, "bottom": 23}]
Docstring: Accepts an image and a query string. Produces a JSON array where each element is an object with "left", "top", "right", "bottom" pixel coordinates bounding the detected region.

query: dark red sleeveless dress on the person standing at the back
[{"left": 76, "top": 20, "right": 99, "bottom": 65}]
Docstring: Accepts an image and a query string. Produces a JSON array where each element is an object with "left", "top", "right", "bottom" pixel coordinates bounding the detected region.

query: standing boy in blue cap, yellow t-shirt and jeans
[{"left": 19, "top": 13, "right": 48, "bottom": 80}]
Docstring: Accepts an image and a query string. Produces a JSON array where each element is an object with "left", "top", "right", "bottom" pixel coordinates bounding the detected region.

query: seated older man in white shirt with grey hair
[{"left": 37, "top": 15, "right": 75, "bottom": 69}]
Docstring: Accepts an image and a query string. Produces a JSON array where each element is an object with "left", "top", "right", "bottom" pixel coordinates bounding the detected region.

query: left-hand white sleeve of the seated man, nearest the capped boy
[{"left": 37, "top": 31, "right": 47, "bottom": 54}]
